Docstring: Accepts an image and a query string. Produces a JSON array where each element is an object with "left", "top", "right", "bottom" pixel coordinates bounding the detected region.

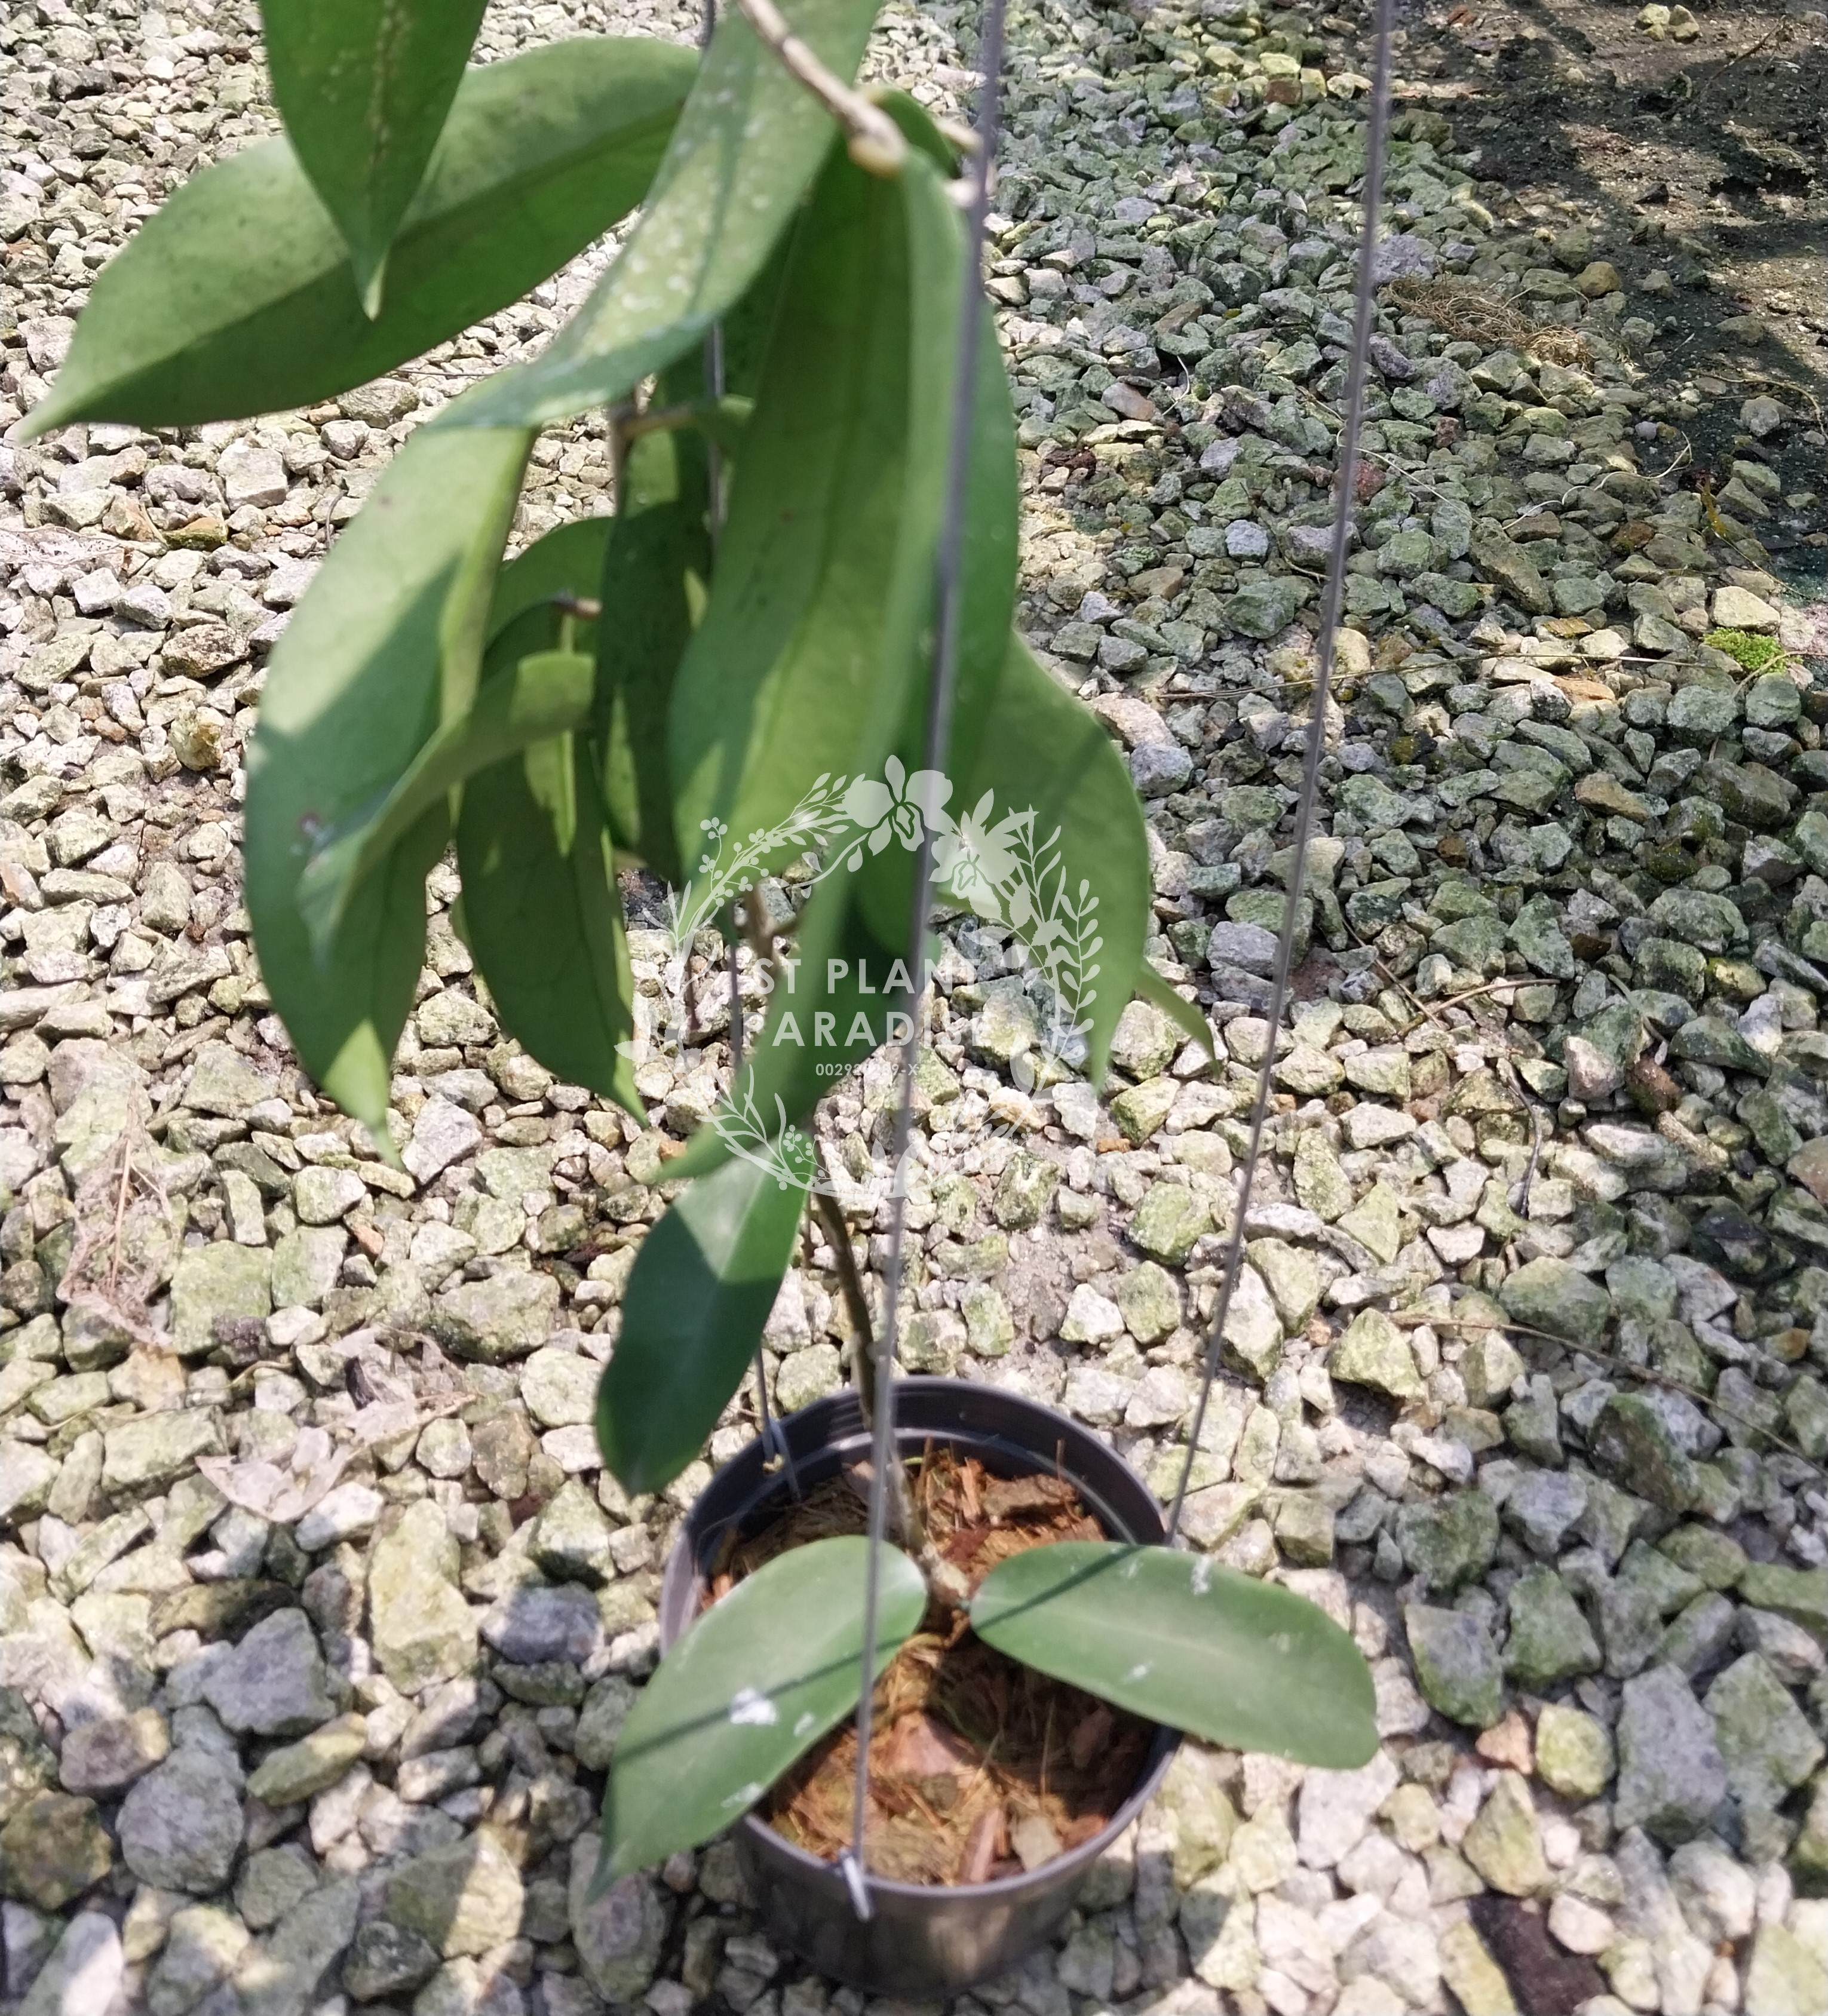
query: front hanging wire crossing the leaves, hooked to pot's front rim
[{"left": 841, "top": 0, "right": 1004, "bottom": 1921}]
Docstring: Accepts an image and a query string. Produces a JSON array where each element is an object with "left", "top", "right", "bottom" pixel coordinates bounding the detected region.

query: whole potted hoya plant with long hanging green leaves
[{"left": 30, "top": 0, "right": 1375, "bottom": 1869}]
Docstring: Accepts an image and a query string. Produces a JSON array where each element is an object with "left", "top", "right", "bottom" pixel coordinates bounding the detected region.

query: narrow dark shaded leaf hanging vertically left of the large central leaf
[{"left": 597, "top": 428, "right": 711, "bottom": 887}]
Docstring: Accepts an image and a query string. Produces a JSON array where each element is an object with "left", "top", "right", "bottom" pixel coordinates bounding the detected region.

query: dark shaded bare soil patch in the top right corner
[{"left": 1358, "top": 0, "right": 1828, "bottom": 576}]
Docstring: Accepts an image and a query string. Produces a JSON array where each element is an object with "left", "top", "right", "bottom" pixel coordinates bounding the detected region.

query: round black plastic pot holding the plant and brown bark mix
[{"left": 661, "top": 1379, "right": 1179, "bottom": 1998}]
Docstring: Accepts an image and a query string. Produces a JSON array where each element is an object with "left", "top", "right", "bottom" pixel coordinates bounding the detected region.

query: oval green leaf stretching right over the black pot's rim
[{"left": 971, "top": 1541, "right": 1376, "bottom": 1770}]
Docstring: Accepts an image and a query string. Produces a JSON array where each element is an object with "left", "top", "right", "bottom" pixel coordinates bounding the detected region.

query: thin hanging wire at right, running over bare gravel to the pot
[{"left": 1167, "top": 0, "right": 1397, "bottom": 1546}]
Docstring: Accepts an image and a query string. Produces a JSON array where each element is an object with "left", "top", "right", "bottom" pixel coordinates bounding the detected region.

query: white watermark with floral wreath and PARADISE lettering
[{"left": 625, "top": 756, "right": 1105, "bottom": 1202}]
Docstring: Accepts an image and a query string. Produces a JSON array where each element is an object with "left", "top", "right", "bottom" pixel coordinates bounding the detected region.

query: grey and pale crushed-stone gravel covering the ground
[{"left": 0, "top": 0, "right": 1828, "bottom": 2016}]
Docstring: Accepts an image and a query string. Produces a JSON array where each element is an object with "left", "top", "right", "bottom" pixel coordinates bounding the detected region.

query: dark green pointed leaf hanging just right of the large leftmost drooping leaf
[{"left": 458, "top": 734, "right": 647, "bottom": 1117}]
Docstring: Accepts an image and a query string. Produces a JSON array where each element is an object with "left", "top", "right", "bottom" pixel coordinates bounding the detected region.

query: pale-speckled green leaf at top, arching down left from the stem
[{"left": 441, "top": 0, "right": 877, "bottom": 428}]
